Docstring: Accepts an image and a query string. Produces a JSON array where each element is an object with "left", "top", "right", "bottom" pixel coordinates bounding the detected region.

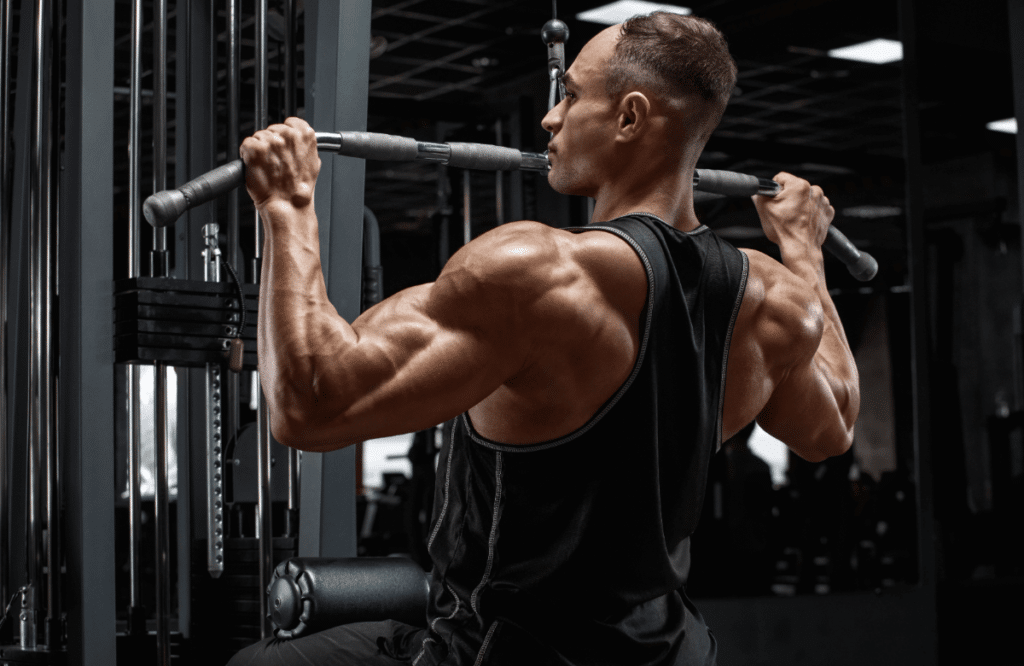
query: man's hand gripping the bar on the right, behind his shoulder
[{"left": 753, "top": 171, "right": 836, "bottom": 248}]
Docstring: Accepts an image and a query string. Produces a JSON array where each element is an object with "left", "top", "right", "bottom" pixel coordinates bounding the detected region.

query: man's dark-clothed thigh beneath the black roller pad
[{"left": 227, "top": 620, "right": 427, "bottom": 666}]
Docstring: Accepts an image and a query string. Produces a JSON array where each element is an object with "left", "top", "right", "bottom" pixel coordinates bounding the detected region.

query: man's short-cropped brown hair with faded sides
[{"left": 605, "top": 11, "right": 736, "bottom": 144}]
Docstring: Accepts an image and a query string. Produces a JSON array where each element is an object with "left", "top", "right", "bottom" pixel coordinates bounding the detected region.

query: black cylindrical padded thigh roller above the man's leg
[{"left": 267, "top": 557, "right": 430, "bottom": 638}]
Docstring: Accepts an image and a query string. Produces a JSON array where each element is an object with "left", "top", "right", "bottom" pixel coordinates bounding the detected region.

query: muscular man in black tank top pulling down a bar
[{"left": 232, "top": 13, "right": 859, "bottom": 666}]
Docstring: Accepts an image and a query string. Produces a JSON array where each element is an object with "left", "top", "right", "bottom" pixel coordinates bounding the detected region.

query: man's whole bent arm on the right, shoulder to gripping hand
[{"left": 723, "top": 173, "right": 860, "bottom": 462}]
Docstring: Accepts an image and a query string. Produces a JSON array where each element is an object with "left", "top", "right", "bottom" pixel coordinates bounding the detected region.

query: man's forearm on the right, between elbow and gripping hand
[{"left": 779, "top": 235, "right": 860, "bottom": 429}]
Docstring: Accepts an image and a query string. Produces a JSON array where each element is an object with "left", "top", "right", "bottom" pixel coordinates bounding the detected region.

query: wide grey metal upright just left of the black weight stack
[{"left": 59, "top": 0, "right": 116, "bottom": 664}]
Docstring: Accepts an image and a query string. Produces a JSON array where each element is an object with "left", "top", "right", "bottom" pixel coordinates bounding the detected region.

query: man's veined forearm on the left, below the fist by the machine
[{"left": 258, "top": 196, "right": 356, "bottom": 432}]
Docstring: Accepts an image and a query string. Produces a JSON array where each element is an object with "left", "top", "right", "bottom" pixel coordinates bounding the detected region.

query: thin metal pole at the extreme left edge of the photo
[{"left": 0, "top": 0, "right": 11, "bottom": 603}]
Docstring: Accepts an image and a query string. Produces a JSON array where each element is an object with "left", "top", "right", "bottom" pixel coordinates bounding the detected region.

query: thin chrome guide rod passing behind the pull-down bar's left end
[{"left": 152, "top": 0, "right": 171, "bottom": 666}]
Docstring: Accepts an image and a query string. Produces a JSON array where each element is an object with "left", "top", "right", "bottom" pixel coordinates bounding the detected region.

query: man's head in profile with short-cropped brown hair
[{"left": 542, "top": 12, "right": 736, "bottom": 197}]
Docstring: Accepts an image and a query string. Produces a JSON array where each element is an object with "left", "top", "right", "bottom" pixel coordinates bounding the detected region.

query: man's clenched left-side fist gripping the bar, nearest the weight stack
[{"left": 239, "top": 118, "right": 321, "bottom": 209}]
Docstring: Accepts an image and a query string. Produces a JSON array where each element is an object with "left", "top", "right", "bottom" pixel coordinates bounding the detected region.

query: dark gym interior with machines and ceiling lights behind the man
[{"left": 0, "top": 0, "right": 1024, "bottom": 666}]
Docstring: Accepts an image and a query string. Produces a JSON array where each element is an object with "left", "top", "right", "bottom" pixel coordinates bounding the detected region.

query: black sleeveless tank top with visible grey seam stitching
[{"left": 413, "top": 213, "right": 748, "bottom": 666}]
